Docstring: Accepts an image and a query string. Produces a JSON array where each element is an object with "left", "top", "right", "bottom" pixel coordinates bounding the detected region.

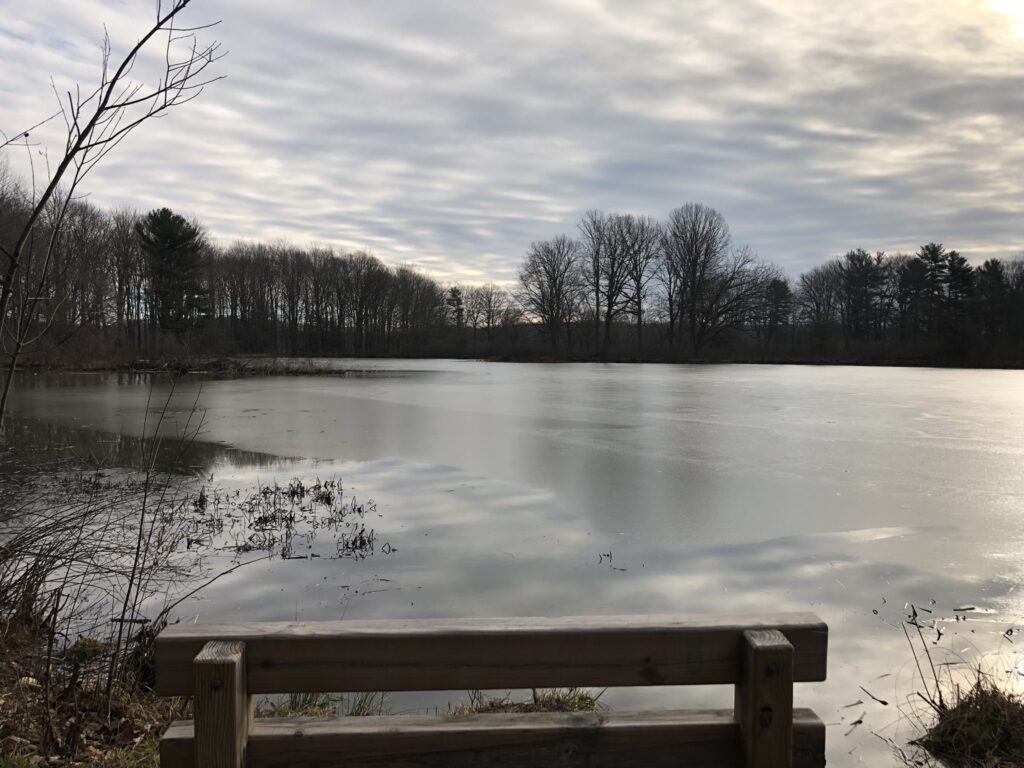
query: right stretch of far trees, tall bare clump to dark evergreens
[{"left": 519, "top": 203, "right": 1024, "bottom": 365}]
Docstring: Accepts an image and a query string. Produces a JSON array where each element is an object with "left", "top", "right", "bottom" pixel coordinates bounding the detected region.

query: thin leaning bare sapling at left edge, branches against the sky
[{"left": 0, "top": 0, "right": 222, "bottom": 425}]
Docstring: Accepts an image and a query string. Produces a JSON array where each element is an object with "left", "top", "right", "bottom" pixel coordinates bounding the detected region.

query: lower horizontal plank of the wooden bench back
[{"left": 160, "top": 710, "right": 825, "bottom": 768}]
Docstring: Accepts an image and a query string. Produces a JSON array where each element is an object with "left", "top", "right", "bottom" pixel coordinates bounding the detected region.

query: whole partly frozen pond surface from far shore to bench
[{"left": 8, "top": 360, "right": 1024, "bottom": 766}]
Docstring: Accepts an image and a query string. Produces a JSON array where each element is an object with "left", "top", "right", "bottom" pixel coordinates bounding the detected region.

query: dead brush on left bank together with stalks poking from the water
[{"left": 0, "top": 448, "right": 392, "bottom": 768}]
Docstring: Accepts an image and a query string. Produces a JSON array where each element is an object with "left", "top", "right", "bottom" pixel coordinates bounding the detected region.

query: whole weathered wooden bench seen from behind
[{"left": 157, "top": 613, "right": 827, "bottom": 768}]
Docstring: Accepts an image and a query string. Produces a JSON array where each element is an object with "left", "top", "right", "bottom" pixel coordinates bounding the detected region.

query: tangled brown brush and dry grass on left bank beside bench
[{"left": 0, "top": 454, "right": 205, "bottom": 768}]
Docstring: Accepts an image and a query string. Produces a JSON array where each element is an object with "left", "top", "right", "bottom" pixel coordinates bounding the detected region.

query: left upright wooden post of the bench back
[{"left": 193, "top": 640, "right": 251, "bottom": 768}]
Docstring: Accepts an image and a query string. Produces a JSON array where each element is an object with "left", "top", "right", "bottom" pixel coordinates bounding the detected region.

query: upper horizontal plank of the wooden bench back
[{"left": 156, "top": 613, "right": 828, "bottom": 696}]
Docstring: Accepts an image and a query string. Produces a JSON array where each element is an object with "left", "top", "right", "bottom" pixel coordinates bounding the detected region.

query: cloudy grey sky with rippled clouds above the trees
[{"left": 0, "top": 0, "right": 1024, "bottom": 282}]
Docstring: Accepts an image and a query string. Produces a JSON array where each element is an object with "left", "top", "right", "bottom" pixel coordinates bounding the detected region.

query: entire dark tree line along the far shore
[{"left": 0, "top": 169, "right": 1024, "bottom": 365}]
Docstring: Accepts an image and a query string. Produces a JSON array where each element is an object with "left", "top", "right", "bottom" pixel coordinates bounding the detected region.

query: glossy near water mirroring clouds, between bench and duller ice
[{"left": 183, "top": 461, "right": 1014, "bottom": 765}]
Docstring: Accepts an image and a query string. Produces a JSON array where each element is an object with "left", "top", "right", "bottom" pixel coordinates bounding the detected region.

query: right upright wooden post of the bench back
[{"left": 736, "top": 630, "right": 793, "bottom": 768}]
